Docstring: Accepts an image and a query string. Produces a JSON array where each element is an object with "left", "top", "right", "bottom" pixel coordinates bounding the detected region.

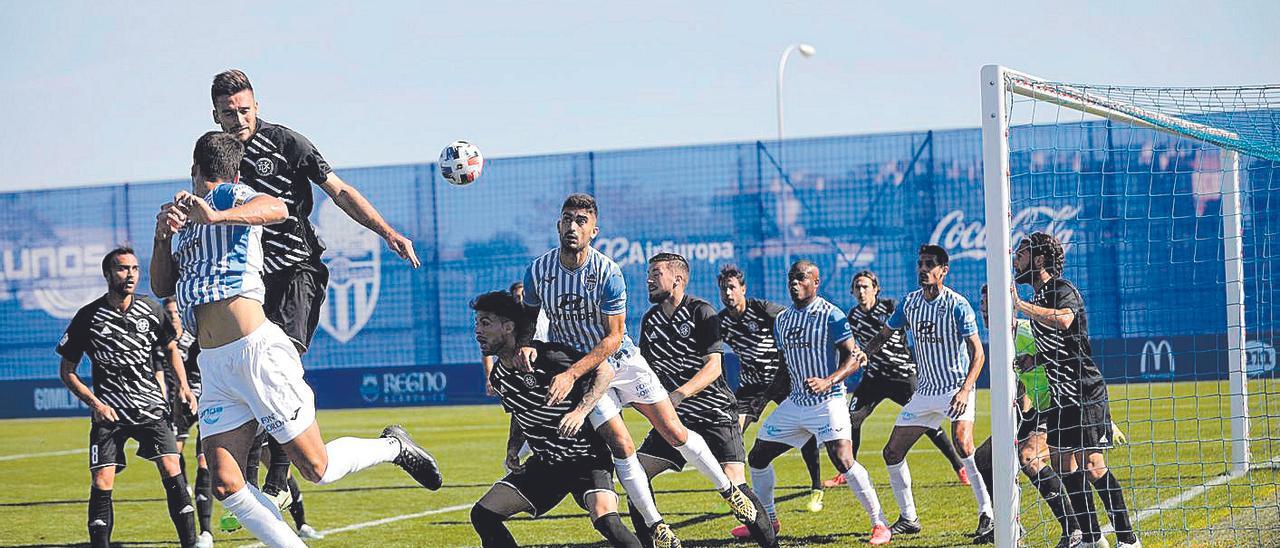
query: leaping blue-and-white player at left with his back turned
[{"left": 151, "top": 132, "right": 440, "bottom": 547}]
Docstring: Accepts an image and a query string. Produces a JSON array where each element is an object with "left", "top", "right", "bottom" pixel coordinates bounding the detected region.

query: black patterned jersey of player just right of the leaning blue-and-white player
[{"left": 640, "top": 294, "right": 737, "bottom": 425}]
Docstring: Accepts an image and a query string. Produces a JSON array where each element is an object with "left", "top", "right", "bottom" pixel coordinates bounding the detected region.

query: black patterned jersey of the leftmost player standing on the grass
[{"left": 58, "top": 294, "right": 173, "bottom": 424}]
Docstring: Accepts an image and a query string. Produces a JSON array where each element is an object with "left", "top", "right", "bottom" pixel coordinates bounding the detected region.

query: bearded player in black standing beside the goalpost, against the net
[{"left": 1010, "top": 232, "right": 1142, "bottom": 548}]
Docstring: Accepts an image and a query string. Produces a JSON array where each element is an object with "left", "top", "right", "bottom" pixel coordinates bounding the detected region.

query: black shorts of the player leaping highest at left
[{"left": 262, "top": 260, "right": 329, "bottom": 352}]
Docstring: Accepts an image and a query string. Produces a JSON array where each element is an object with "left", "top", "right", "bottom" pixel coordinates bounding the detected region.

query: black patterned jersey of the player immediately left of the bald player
[{"left": 719, "top": 298, "right": 785, "bottom": 387}]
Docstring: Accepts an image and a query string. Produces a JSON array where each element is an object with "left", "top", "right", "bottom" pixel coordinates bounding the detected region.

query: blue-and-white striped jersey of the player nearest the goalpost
[{"left": 886, "top": 286, "right": 978, "bottom": 396}]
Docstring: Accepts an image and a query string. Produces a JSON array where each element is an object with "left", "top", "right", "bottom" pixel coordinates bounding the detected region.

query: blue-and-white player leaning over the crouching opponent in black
[{"left": 516, "top": 193, "right": 756, "bottom": 547}]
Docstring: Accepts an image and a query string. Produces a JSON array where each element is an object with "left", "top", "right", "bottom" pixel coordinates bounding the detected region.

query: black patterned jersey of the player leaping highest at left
[{"left": 241, "top": 118, "right": 333, "bottom": 274}]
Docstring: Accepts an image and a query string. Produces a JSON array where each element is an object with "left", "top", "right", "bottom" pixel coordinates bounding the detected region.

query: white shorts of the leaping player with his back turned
[{"left": 200, "top": 321, "right": 316, "bottom": 443}]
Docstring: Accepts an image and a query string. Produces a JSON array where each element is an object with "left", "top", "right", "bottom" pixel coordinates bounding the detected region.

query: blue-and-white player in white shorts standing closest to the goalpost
[{"left": 867, "top": 245, "right": 995, "bottom": 536}]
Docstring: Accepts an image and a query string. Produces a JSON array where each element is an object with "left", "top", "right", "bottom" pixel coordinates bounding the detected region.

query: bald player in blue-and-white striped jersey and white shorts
[{"left": 746, "top": 260, "right": 891, "bottom": 544}]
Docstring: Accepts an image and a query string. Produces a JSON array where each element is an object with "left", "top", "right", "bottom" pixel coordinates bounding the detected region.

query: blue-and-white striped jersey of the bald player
[{"left": 773, "top": 297, "right": 854, "bottom": 406}]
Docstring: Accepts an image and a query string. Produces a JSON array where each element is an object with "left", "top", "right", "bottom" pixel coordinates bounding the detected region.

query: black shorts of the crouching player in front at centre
[{"left": 498, "top": 453, "right": 617, "bottom": 517}]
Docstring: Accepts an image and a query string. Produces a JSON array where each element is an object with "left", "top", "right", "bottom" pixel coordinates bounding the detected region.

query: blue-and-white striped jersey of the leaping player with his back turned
[{"left": 173, "top": 183, "right": 266, "bottom": 333}]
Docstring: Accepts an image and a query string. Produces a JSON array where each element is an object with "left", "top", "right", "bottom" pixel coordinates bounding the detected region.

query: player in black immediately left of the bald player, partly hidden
[{"left": 716, "top": 265, "right": 824, "bottom": 514}]
